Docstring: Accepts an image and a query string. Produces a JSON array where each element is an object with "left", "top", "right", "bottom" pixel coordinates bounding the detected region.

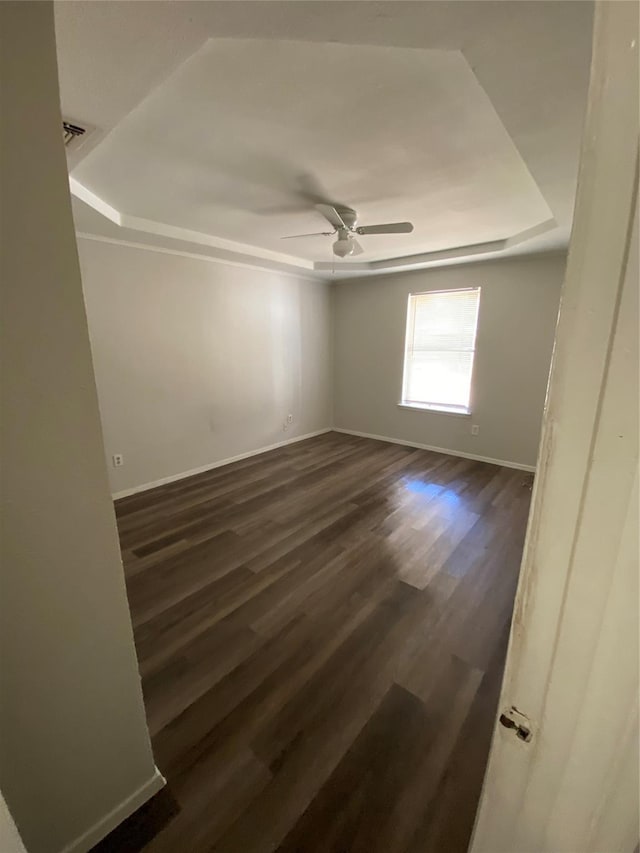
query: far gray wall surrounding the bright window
[{"left": 333, "top": 253, "right": 566, "bottom": 466}]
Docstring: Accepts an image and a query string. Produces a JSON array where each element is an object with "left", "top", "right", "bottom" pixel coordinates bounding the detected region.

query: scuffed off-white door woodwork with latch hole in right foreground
[{"left": 471, "top": 0, "right": 638, "bottom": 853}]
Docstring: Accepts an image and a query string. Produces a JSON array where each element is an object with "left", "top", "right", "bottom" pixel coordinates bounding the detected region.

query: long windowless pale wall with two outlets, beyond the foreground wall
[{"left": 79, "top": 239, "right": 331, "bottom": 493}]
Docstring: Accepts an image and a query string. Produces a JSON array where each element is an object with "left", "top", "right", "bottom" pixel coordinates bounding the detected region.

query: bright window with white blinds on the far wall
[{"left": 400, "top": 287, "right": 480, "bottom": 414}]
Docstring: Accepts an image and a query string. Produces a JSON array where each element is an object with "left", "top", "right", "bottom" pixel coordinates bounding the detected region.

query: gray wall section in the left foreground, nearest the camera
[{"left": 0, "top": 2, "right": 159, "bottom": 853}]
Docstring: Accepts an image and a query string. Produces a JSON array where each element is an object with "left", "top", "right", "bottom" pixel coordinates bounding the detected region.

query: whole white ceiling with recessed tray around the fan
[{"left": 56, "top": 0, "right": 592, "bottom": 274}]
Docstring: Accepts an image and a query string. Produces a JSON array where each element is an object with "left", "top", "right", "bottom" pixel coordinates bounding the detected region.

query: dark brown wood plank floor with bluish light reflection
[{"left": 111, "top": 433, "right": 532, "bottom": 853}]
